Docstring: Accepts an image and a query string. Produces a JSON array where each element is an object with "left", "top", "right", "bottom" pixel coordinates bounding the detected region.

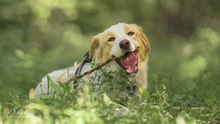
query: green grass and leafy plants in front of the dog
[{"left": 0, "top": 67, "right": 220, "bottom": 124}]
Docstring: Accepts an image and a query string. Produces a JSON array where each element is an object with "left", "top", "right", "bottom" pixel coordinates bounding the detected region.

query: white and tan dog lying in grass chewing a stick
[{"left": 35, "top": 23, "right": 150, "bottom": 97}]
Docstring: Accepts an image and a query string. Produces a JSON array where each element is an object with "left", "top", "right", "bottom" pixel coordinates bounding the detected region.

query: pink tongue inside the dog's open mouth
[{"left": 121, "top": 52, "right": 137, "bottom": 72}]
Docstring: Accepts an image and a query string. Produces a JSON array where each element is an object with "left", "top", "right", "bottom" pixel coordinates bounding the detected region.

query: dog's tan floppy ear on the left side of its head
[{"left": 89, "top": 35, "right": 100, "bottom": 59}]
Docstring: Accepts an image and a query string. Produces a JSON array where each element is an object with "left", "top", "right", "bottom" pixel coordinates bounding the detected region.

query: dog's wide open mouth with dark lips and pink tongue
[{"left": 115, "top": 51, "right": 138, "bottom": 76}]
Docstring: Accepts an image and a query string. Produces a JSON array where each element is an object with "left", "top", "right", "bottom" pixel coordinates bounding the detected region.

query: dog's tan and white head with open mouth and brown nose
[{"left": 89, "top": 23, "right": 150, "bottom": 75}]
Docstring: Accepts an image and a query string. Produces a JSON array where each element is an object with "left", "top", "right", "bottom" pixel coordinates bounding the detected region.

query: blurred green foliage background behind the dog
[{"left": 0, "top": 0, "right": 220, "bottom": 98}]
